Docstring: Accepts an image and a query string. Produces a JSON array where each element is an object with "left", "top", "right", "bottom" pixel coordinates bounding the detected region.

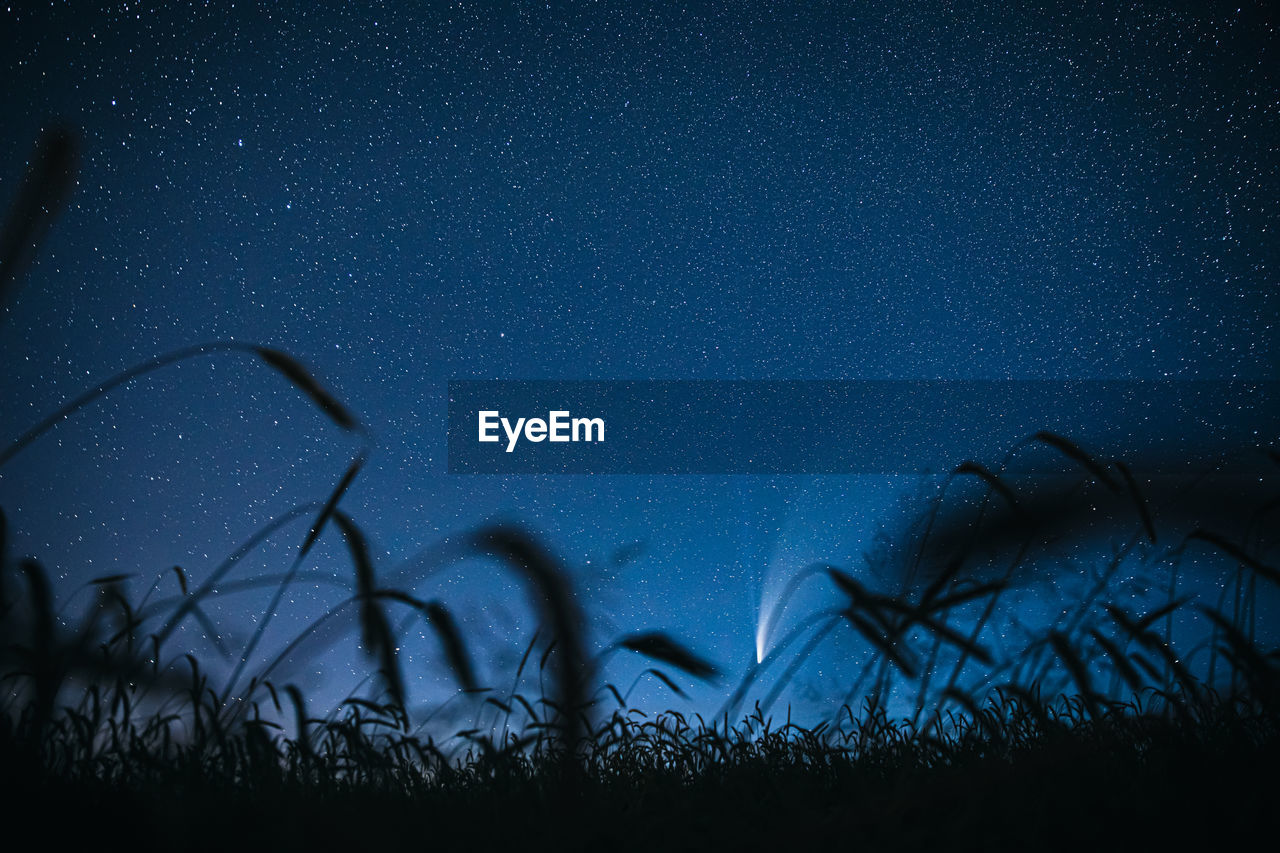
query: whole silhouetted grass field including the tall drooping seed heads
[{"left": 0, "top": 126, "right": 1280, "bottom": 849}]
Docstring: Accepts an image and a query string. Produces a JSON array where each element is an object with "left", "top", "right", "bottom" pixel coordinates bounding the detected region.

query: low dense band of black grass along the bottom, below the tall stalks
[{"left": 3, "top": 666, "right": 1280, "bottom": 850}]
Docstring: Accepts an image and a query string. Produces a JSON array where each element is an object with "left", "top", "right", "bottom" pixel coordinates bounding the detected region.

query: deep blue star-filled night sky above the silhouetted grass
[{"left": 0, "top": 0, "right": 1280, "bottom": 722}]
